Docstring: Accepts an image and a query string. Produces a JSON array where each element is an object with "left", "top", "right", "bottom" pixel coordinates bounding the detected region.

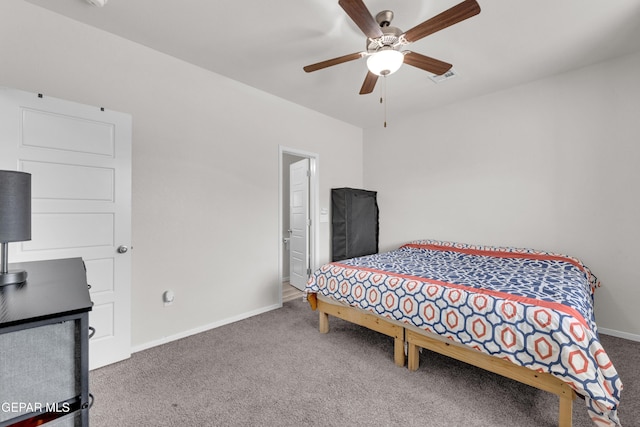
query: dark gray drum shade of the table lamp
[{"left": 0, "top": 170, "right": 31, "bottom": 243}]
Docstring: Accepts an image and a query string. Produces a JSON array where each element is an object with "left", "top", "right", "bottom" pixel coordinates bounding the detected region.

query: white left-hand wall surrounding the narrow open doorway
[{"left": 0, "top": 0, "right": 363, "bottom": 349}]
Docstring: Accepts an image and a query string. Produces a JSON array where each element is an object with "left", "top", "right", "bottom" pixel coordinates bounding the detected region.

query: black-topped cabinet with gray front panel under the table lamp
[{"left": 0, "top": 258, "right": 92, "bottom": 427}]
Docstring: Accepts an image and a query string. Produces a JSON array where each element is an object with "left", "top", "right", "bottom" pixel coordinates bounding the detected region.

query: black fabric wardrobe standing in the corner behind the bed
[{"left": 331, "top": 188, "right": 379, "bottom": 261}]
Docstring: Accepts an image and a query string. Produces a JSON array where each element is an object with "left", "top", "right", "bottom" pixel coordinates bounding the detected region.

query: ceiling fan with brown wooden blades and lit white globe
[{"left": 303, "top": 0, "right": 480, "bottom": 95}]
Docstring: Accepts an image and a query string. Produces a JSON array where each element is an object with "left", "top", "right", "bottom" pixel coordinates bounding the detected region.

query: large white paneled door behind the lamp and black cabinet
[{"left": 0, "top": 88, "right": 131, "bottom": 369}]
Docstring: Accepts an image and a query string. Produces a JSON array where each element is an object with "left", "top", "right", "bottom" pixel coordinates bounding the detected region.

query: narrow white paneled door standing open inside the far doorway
[{"left": 289, "top": 159, "right": 311, "bottom": 290}]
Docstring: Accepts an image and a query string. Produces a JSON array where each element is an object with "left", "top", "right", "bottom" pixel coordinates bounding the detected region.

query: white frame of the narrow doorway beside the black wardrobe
[{"left": 278, "top": 146, "right": 319, "bottom": 303}]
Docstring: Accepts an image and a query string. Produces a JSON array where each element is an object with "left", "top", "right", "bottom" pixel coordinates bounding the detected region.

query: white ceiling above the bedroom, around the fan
[{"left": 25, "top": 0, "right": 640, "bottom": 128}]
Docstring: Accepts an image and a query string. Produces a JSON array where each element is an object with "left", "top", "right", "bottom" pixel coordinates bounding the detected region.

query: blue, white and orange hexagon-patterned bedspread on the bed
[{"left": 307, "top": 240, "right": 622, "bottom": 426}]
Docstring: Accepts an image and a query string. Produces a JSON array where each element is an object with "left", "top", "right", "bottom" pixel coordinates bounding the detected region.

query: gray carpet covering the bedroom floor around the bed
[{"left": 90, "top": 300, "right": 640, "bottom": 427}]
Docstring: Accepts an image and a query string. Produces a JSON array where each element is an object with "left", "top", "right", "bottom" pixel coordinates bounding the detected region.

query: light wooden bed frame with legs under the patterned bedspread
[{"left": 307, "top": 294, "right": 576, "bottom": 427}]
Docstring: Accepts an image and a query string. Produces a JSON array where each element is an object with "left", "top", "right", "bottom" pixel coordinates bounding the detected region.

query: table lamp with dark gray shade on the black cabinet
[{"left": 0, "top": 170, "right": 31, "bottom": 286}]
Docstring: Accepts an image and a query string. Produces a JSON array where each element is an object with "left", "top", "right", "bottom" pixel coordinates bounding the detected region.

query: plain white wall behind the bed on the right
[{"left": 364, "top": 50, "right": 640, "bottom": 339}]
